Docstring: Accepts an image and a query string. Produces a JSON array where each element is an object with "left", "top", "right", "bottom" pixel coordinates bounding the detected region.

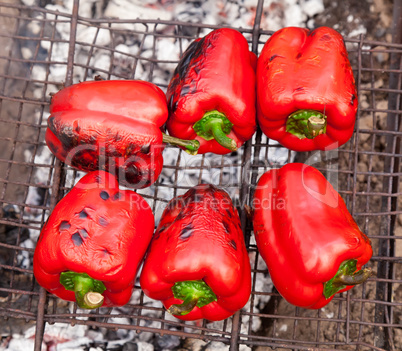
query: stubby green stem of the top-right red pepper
[{"left": 286, "top": 110, "right": 327, "bottom": 139}]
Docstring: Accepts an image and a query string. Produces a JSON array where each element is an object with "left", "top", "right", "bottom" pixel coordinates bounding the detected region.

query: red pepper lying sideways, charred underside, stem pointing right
[{"left": 46, "top": 80, "right": 198, "bottom": 188}]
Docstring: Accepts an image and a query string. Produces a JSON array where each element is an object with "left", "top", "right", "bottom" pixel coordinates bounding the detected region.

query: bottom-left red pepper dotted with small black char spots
[{"left": 33, "top": 171, "right": 154, "bottom": 308}]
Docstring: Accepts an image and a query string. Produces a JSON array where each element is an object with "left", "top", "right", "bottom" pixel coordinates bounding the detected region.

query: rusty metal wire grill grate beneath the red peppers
[{"left": 0, "top": 0, "right": 402, "bottom": 351}]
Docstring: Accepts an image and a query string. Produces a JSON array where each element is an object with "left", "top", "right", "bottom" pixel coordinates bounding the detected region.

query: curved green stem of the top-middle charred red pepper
[{"left": 193, "top": 110, "right": 237, "bottom": 151}]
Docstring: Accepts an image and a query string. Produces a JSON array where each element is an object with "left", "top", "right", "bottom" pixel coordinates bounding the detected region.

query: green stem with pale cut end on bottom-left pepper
[{"left": 60, "top": 271, "right": 106, "bottom": 309}]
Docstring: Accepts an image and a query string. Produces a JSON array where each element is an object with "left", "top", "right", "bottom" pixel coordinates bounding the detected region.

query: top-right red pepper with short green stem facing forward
[{"left": 257, "top": 27, "right": 358, "bottom": 151}]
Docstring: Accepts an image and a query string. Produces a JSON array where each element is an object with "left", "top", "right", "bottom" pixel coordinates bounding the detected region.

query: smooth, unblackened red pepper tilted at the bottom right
[{"left": 253, "top": 163, "right": 373, "bottom": 309}]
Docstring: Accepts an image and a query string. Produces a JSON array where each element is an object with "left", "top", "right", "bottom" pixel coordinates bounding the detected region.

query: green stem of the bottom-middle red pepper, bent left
[{"left": 168, "top": 280, "right": 217, "bottom": 316}]
